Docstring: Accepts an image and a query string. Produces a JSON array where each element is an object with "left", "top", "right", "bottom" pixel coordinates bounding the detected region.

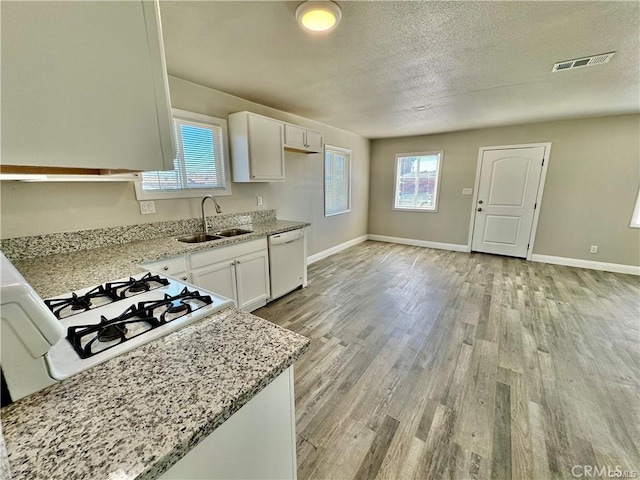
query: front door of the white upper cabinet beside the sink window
[{"left": 248, "top": 115, "right": 284, "bottom": 181}]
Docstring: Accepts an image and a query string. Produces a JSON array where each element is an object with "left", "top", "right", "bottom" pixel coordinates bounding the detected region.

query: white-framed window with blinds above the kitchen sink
[{"left": 136, "top": 108, "right": 231, "bottom": 200}]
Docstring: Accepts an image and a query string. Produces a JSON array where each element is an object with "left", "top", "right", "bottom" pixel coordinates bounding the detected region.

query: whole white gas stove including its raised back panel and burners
[{"left": 0, "top": 255, "right": 234, "bottom": 401}]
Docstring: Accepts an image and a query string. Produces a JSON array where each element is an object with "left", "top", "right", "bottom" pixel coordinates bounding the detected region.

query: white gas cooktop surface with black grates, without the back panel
[{"left": 44, "top": 273, "right": 234, "bottom": 380}]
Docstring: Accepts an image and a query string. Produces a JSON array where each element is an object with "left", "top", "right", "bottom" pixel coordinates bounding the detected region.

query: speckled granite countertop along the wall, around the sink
[{"left": 11, "top": 220, "right": 310, "bottom": 298}]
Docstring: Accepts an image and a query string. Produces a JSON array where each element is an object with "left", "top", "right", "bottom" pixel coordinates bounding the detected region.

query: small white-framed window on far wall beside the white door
[{"left": 393, "top": 151, "right": 444, "bottom": 212}]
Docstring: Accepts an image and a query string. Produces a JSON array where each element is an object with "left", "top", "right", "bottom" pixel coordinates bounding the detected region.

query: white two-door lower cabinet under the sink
[{"left": 189, "top": 238, "right": 271, "bottom": 312}]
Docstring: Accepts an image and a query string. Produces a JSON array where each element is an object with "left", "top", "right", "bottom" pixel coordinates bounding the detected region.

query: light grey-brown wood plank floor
[{"left": 254, "top": 241, "right": 640, "bottom": 480}]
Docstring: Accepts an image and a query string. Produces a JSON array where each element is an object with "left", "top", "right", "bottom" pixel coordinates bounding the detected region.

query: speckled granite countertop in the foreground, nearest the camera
[{"left": 1, "top": 308, "right": 309, "bottom": 480}]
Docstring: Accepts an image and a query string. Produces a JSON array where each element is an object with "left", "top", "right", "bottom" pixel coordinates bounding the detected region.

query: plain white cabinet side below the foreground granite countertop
[{"left": 160, "top": 366, "right": 297, "bottom": 480}]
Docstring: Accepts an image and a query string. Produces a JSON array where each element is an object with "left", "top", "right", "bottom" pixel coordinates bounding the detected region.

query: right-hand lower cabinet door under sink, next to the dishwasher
[{"left": 236, "top": 250, "right": 271, "bottom": 309}]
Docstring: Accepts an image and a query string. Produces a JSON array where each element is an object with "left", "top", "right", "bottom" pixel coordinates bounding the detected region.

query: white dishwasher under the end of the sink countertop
[{"left": 269, "top": 229, "right": 307, "bottom": 300}]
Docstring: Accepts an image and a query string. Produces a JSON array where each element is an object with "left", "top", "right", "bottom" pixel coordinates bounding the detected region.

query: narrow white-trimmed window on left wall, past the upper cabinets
[{"left": 324, "top": 145, "right": 351, "bottom": 217}]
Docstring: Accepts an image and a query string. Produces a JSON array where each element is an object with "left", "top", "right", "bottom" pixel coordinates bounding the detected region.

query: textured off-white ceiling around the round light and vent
[{"left": 160, "top": 1, "right": 640, "bottom": 138}]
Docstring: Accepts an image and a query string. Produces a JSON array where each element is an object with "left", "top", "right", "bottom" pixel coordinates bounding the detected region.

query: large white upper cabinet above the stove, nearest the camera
[{"left": 1, "top": 1, "right": 174, "bottom": 173}]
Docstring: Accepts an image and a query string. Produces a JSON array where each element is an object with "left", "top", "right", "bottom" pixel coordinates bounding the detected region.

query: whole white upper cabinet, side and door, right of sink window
[{"left": 228, "top": 112, "right": 284, "bottom": 182}]
